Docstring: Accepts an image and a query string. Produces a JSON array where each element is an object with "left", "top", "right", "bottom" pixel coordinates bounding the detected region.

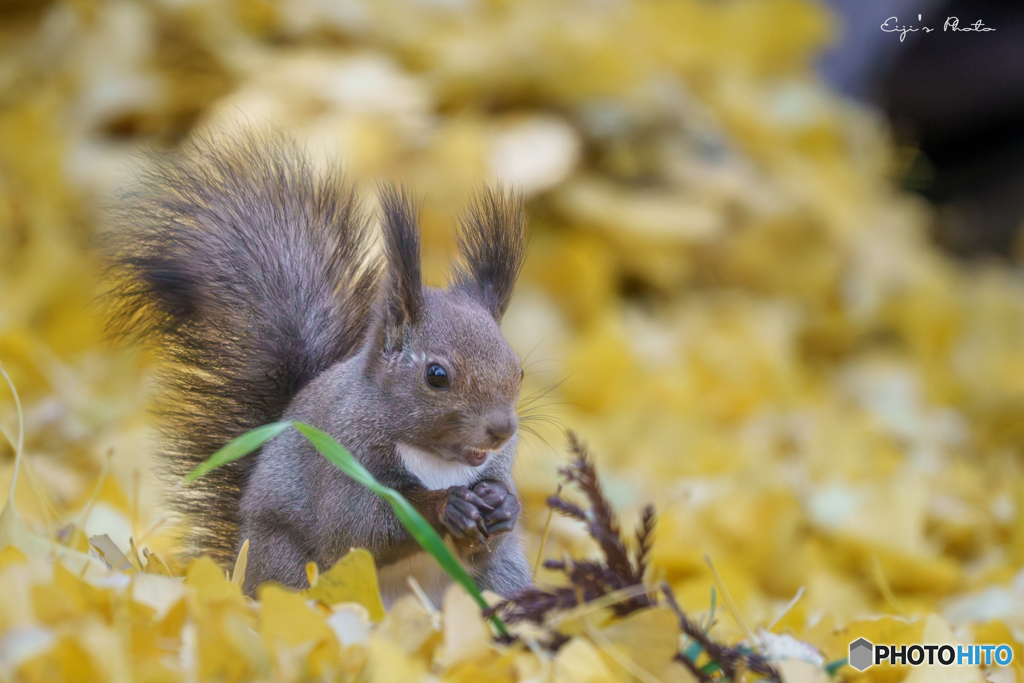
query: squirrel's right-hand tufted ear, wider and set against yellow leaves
[{"left": 453, "top": 188, "right": 526, "bottom": 323}]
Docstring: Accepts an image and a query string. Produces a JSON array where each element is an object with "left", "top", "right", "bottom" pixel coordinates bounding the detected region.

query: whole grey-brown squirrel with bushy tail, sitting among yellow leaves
[{"left": 105, "top": 136, "right": 530, "bottom": 598}]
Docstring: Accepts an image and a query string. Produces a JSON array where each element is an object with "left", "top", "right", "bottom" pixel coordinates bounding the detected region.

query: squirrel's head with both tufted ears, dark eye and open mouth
[{"left": 367, "top": 187, "right": 525, "bottom": 466}]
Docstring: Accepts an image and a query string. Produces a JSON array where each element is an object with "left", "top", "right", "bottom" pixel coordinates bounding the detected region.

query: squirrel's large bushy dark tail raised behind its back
[{"left": 104, "top": 137, "right": 379, "bottom": 563}]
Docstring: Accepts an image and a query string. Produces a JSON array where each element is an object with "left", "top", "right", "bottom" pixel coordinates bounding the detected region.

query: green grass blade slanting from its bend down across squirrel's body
[{"left": 295, "top": 422, "right": 508, "bottom": 636}]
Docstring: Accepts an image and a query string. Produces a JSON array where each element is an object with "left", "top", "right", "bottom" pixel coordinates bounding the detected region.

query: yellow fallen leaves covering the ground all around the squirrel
[{"left": 0, "top": 0, "right": 1024, "bottom": 683}]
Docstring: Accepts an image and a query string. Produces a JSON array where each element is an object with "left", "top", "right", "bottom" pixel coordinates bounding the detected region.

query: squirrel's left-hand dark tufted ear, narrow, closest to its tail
[{"left": 379, "top": 184, "right": 423, "bottom": 340}]
